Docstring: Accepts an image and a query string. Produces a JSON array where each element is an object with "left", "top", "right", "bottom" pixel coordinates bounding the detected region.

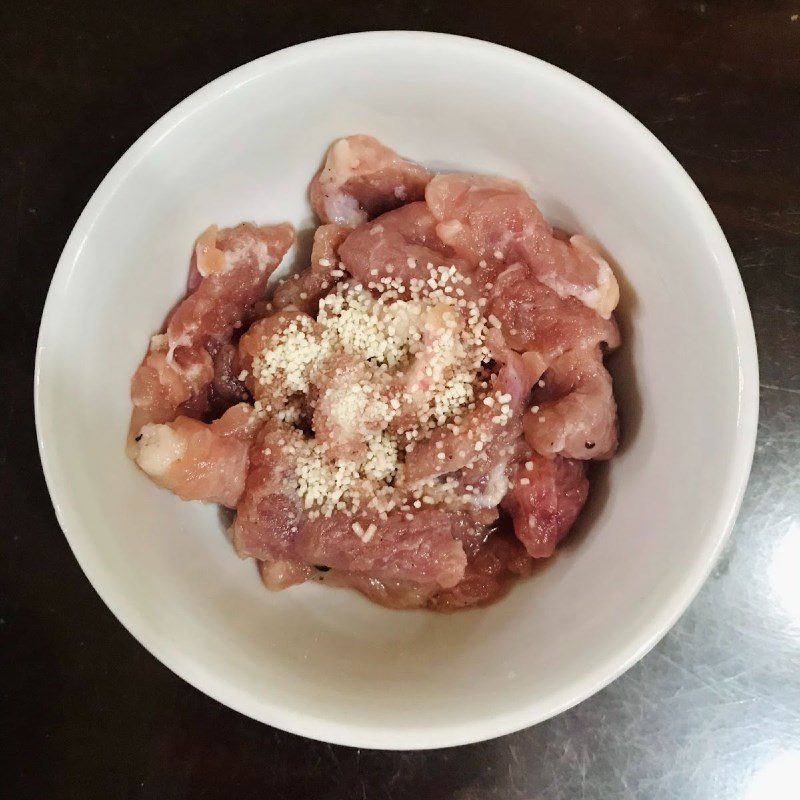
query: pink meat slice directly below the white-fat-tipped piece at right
[{"left": 488, "top": 264, "right": 620, "bottom": 372}]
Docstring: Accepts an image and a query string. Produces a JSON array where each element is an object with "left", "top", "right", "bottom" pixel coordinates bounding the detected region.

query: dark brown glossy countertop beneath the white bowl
[{"left": 0, "top": 0, "right": 800, "bottom": 800}]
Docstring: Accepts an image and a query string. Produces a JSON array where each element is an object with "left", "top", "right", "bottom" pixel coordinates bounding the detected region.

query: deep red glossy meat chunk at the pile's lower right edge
[{"left": 502, "top": 453, "right": 589, "bottom": 558}]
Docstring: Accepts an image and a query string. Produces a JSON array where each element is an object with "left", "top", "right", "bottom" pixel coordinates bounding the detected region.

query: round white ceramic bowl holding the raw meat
[{"left": 36, "top": 33, "right": 758, "bottom": 749}]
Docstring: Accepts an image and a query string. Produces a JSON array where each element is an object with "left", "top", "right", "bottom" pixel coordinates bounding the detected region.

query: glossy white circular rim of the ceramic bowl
[{"left": 34, "top": 31, "right": 759, "bottom": 750}]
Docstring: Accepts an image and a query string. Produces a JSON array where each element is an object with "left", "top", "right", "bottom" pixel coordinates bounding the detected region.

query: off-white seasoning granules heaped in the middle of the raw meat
[{"left": 251, "top": 259, "right": 500, "bottom": 520}]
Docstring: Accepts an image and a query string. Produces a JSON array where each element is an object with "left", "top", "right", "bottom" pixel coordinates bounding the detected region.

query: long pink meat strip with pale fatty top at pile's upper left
[{"left": 131, "top": 223, "right": 294, "bottom": 436}]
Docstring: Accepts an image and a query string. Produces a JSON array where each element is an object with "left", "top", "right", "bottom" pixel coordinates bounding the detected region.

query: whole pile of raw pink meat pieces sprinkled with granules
[{"left": 129, "top": 136, "right": 620, "bottom": 611}]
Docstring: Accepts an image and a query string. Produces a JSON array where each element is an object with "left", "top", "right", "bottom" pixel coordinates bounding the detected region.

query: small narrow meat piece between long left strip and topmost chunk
[{"left": 272, "top": 224, "right": 350, "bottom": 314}]
